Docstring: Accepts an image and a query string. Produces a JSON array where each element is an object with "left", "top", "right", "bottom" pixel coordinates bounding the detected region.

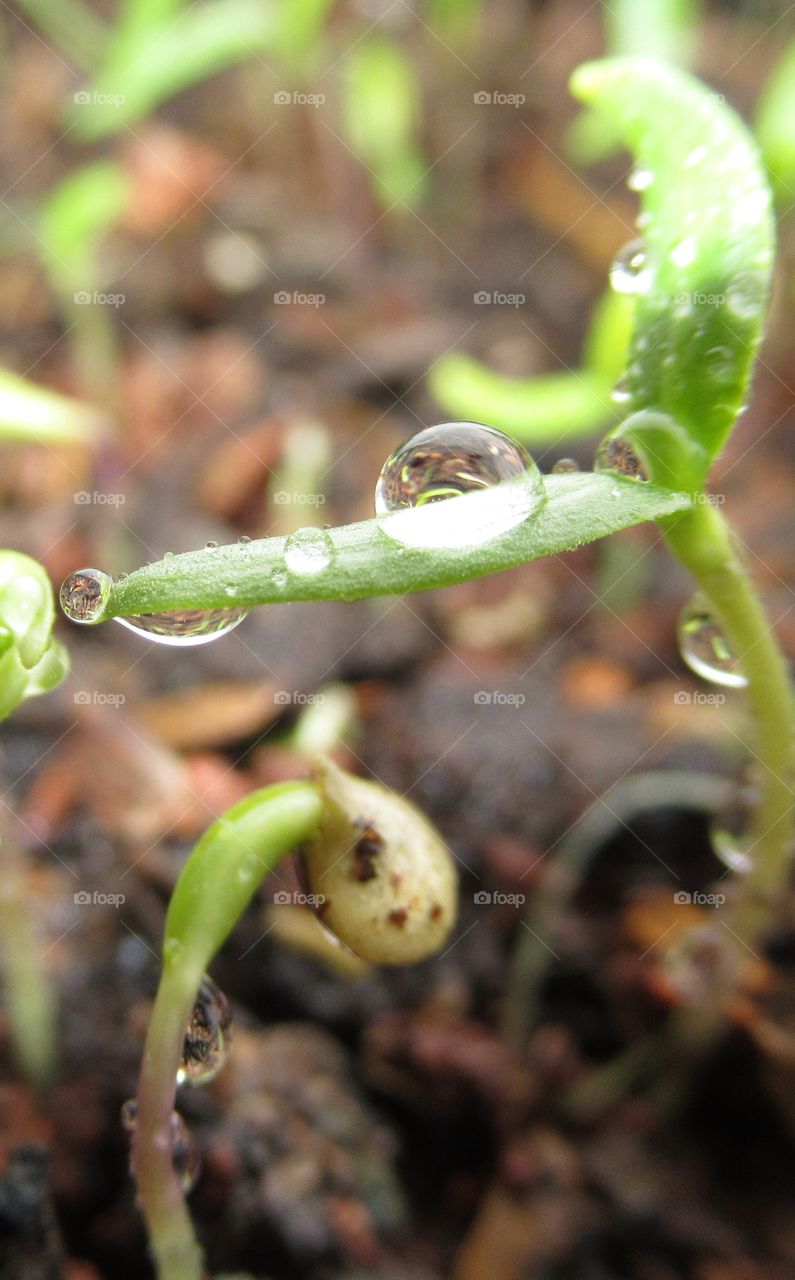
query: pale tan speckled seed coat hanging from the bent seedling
[{"left": 300, "top": 759, "right": 457, "bottom": 964}]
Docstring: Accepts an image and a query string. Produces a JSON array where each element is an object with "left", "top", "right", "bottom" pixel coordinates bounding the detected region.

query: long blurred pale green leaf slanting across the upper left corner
[{"left": 70, "top": 0, "right": 275, "bottom": 140}]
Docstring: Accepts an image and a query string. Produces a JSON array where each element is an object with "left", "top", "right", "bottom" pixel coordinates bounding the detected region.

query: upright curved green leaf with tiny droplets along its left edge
[{"left": 572, "top": 59, "right": 773, "bottom": 489}]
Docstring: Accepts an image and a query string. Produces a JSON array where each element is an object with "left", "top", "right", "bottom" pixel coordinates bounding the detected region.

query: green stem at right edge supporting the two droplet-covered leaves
[{"left": 663, "top": 503, "right": 795, "bottom": 951}]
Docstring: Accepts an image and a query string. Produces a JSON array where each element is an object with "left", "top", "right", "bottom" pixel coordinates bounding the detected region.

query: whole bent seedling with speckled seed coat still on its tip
[{"left": 133, "top": 760, "right": 456, "bottom": 1280}]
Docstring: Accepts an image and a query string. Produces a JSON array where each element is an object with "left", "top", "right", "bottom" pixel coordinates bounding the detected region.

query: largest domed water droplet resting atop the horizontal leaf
[{"left": 375, "top": 422, "right": 545, "bottom": 548}]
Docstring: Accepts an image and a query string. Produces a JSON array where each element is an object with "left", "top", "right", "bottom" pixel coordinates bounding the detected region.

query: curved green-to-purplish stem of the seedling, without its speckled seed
[{"left": 132, "top": 782, "right": 321, "bottom": 1280}]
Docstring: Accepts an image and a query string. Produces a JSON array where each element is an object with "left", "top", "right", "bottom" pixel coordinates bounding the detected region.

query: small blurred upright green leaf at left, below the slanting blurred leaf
[{"left": 38, "top": 162, "right": 131, "bottom": 293}]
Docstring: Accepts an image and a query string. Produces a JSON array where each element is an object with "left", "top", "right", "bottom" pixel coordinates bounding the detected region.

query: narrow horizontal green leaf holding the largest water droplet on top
[{"left": 104, "top": 472, "right": 689, "bottom": 618}]
